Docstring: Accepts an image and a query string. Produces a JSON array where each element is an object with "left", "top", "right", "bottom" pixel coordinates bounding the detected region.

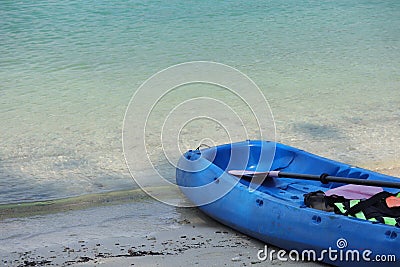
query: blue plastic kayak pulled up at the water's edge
[{"left": 176, "top": 140, "right": 400, "bottom": 266}]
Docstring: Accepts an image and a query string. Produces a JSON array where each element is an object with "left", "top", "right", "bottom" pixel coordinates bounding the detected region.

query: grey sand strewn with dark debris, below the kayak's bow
[{"left": 1, "top": 211, "right": 323, "bottom": 266}]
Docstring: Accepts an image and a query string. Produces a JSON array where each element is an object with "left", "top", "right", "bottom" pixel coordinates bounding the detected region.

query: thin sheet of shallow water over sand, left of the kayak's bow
[{"left": 0, "top": 199, "right": 182, "bottom": 255}]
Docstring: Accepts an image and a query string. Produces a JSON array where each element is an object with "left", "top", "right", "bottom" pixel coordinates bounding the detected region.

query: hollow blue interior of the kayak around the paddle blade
[{"left": 196, "top": 141, "right": 391, "bottom": 202}]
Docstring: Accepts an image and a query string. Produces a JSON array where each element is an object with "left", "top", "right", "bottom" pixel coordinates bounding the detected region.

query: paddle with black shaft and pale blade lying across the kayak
[{"left": 228, "top": 170, "right": 400, "bottom": 189}]
